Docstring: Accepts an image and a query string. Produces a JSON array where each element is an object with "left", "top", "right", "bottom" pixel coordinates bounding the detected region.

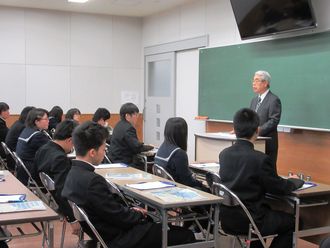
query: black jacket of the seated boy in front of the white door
[{"left": 109, "top": 120, "right": 152, "bottom": 164}]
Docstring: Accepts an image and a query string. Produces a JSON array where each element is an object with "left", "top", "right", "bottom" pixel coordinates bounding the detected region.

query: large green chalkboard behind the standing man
[{"left": 199, "top": 32, "right": 330, "bottom": 129}]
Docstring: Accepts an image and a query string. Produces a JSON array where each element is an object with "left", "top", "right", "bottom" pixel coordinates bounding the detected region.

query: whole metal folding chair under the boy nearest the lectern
[{"left": 212, "top": 182, "right": 277, "bottom": 248}]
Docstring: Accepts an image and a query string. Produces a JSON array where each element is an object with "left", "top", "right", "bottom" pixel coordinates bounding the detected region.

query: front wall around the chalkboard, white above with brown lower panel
[{"left": 142, "top": 0, "right": 330, "bottom": 179}]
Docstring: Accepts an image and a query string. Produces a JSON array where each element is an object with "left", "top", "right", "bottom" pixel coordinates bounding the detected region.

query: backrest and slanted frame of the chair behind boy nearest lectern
[{"left": 212, "top": 183, "right": 266, "bottom": 247}]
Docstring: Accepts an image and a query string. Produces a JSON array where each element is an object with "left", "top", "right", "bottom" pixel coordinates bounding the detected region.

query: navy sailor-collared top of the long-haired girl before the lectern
[{"left": 155, "top": 142, "right": 203, "bottom": 188}]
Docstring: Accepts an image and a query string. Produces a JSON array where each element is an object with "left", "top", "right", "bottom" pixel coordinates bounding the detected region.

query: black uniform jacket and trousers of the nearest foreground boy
[{"left": 62, "top": 160, "right": 152, "bottom": 248}]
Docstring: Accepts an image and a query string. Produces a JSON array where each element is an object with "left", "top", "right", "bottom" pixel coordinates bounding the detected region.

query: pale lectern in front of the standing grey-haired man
[{"left": 195, "top": 132, "right": 269, "bottom": 161}]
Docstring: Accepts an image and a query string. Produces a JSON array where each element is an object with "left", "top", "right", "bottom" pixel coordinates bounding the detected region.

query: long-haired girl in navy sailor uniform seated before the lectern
[{"left": 155, "top": 117, "right": 208, "bottom": 191}]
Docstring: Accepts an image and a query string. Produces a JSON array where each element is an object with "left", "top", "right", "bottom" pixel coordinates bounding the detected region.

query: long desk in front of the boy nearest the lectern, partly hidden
[{"left": 190, "top": 165, "right": 330, "bottom": 247}]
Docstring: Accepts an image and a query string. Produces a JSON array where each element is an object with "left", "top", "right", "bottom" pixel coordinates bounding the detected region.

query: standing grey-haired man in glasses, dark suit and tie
[{"left": 250, "top": 71, "right": 282, "bottom": 169}]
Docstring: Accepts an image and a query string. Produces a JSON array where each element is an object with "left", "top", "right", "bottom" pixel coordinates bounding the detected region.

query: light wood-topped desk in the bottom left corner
[{"left": 0, "top": 171, "right": 60, "bottom": 248}]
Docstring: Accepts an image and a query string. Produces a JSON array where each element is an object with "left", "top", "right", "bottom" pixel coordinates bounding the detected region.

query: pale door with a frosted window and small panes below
[{"left": 144, "top": 52, "right": 175, "bottom": 146}]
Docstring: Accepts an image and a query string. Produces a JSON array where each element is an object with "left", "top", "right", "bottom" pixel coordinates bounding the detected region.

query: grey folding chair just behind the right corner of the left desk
[{"left": 39, "top": 172, "right": 66, "bottom": 248}]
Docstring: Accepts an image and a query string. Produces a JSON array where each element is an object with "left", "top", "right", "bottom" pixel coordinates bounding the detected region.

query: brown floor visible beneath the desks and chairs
[{"left": 4, "top": 221, "right": 318, "bottom": 248}]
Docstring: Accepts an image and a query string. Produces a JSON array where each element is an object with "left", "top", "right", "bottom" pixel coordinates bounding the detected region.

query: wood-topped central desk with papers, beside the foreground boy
[{"left": 95, "top": 167, "right": 221, "bottom": 248}]
